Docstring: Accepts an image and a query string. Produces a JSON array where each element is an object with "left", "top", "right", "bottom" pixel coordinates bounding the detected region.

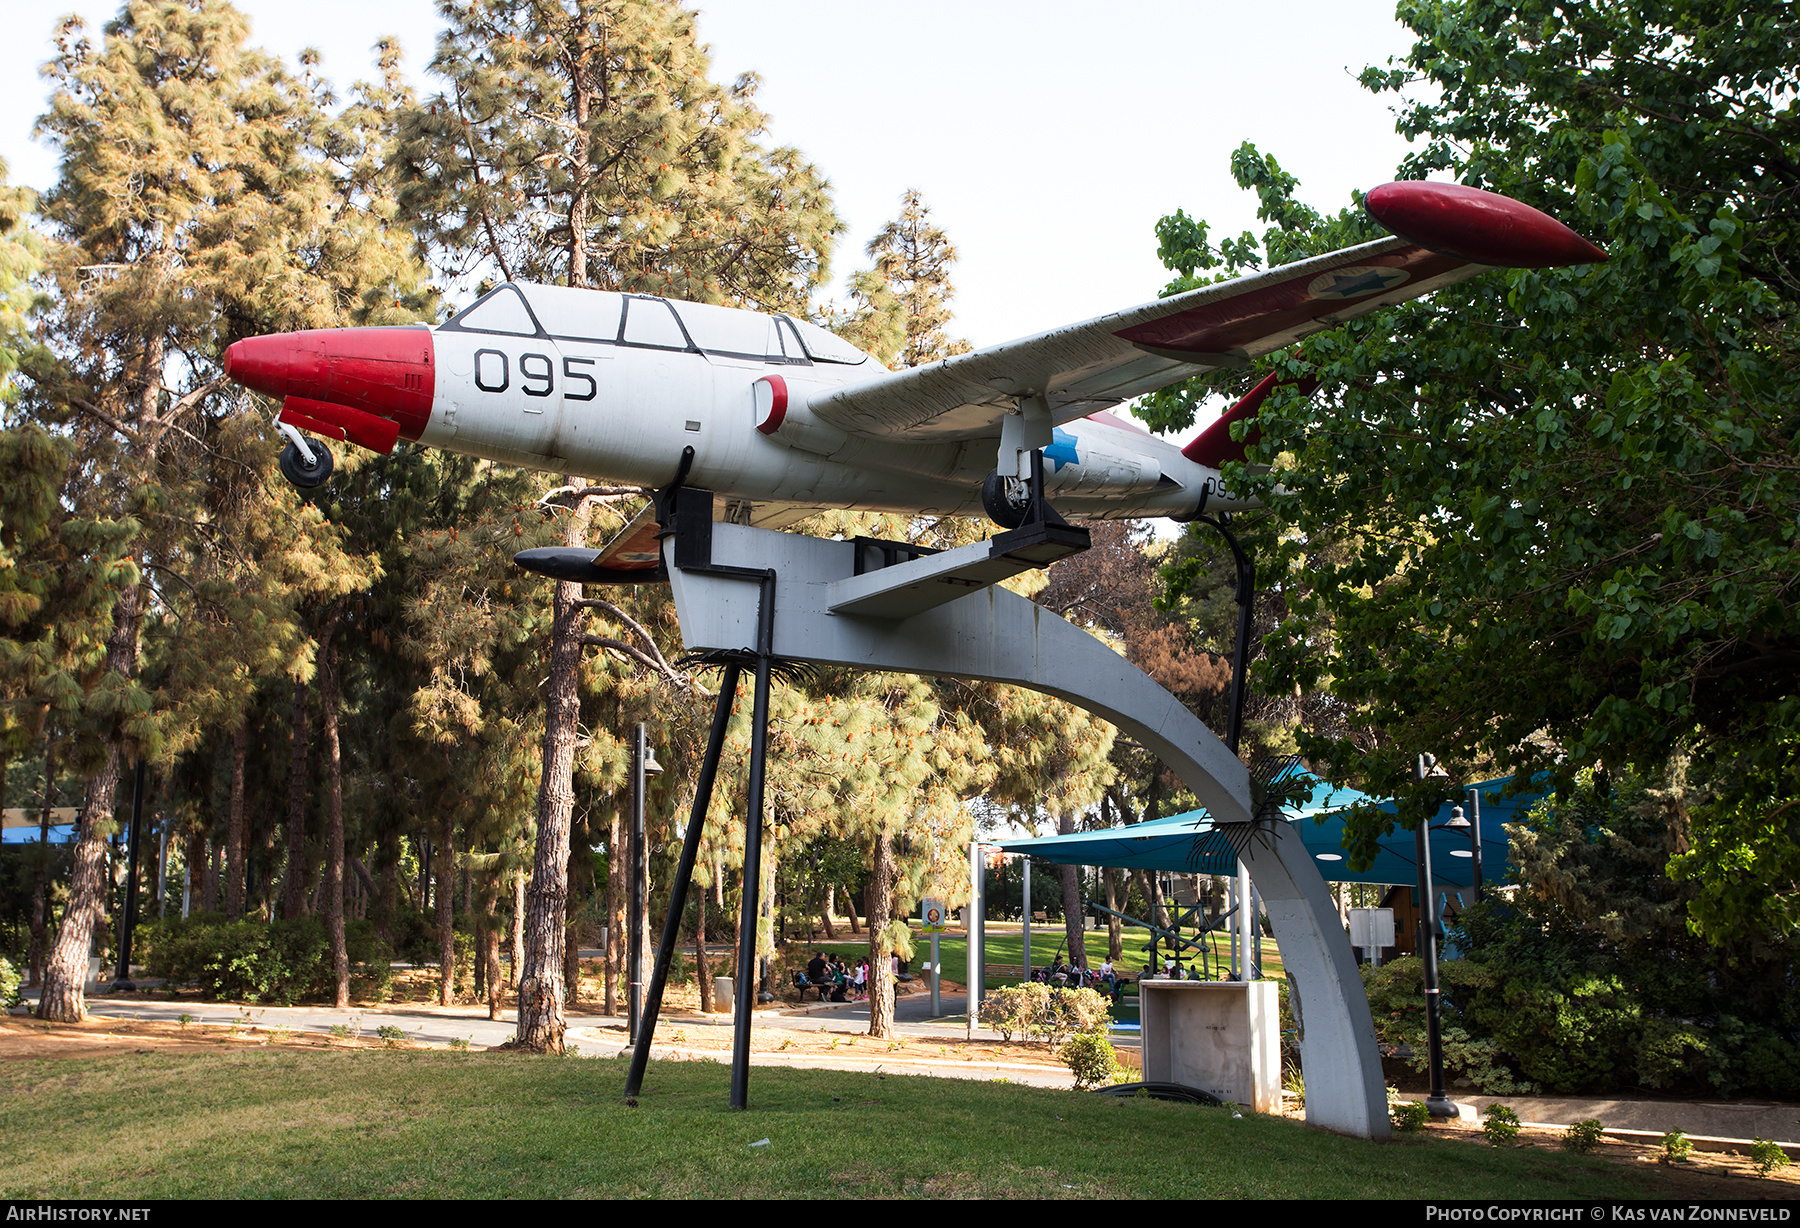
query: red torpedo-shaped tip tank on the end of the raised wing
[{"left": 1363, "top": 180, "right": 1606, "bottom": 268}]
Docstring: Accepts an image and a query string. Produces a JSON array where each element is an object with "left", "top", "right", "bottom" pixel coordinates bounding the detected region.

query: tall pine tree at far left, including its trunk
[{"left": 27, "top": 0, "right": 432, "bottom": 1019}]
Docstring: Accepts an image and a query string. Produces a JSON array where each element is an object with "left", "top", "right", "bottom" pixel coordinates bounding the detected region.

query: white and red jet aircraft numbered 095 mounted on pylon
[{"left": 225, "top": 180, "right": 1606, "bottom": 582}]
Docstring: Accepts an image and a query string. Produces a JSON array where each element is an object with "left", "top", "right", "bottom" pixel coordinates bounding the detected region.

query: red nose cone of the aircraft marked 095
[{"left": 225, "top": 328, "right": 437, "bottom": 452}]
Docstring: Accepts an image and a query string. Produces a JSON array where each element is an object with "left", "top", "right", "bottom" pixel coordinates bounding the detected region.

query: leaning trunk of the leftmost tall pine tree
[{"left": 38, "top": 583, "right": 140, "bottom": 1023}]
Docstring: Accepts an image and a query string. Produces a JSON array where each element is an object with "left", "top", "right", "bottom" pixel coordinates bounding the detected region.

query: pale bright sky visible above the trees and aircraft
[{"left": 0, "top": 0, "right": 1411, "bottom": 378}]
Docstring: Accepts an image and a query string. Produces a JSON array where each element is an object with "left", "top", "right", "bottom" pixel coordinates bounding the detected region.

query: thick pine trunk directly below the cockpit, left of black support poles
[{"left": 515, "top": 500, "right": 590, "bottom": 1053}]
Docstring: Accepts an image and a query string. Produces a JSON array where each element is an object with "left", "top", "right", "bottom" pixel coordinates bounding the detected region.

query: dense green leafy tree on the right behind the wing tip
[{"left": 1147, "top": 0, "right": 1800, "bottom": 878}]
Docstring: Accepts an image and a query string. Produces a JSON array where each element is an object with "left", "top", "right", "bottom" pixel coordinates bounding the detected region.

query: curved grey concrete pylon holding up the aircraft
[{"left": 664, "top": 524, "right": 1388, "bottom": 1138}]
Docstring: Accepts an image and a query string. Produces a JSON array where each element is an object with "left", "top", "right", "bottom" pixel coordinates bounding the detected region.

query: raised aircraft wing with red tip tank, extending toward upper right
[{"left": 808, "top": 180, "right": 1606, "bottom": 443}]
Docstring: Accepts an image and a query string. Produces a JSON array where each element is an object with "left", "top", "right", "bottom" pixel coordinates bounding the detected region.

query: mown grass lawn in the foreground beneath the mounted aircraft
[{"left": 0, "top": 1046, "right": 1699, "bottom": 1199}]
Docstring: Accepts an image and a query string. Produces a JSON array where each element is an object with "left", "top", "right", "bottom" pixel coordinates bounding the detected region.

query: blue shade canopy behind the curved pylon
[{"left": 999, "top": 776, "right": 1541, "bottom": 888}]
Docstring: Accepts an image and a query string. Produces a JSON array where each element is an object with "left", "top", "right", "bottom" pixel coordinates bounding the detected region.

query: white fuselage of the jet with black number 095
[{"left": 419, "top": 286, "right": 1235, "bottom": 519}]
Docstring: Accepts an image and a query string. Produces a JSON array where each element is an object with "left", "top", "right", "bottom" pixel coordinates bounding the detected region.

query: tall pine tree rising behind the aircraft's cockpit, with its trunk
[{"left": 400, "top": 0, "right": 839, "bottom": 1052}]
